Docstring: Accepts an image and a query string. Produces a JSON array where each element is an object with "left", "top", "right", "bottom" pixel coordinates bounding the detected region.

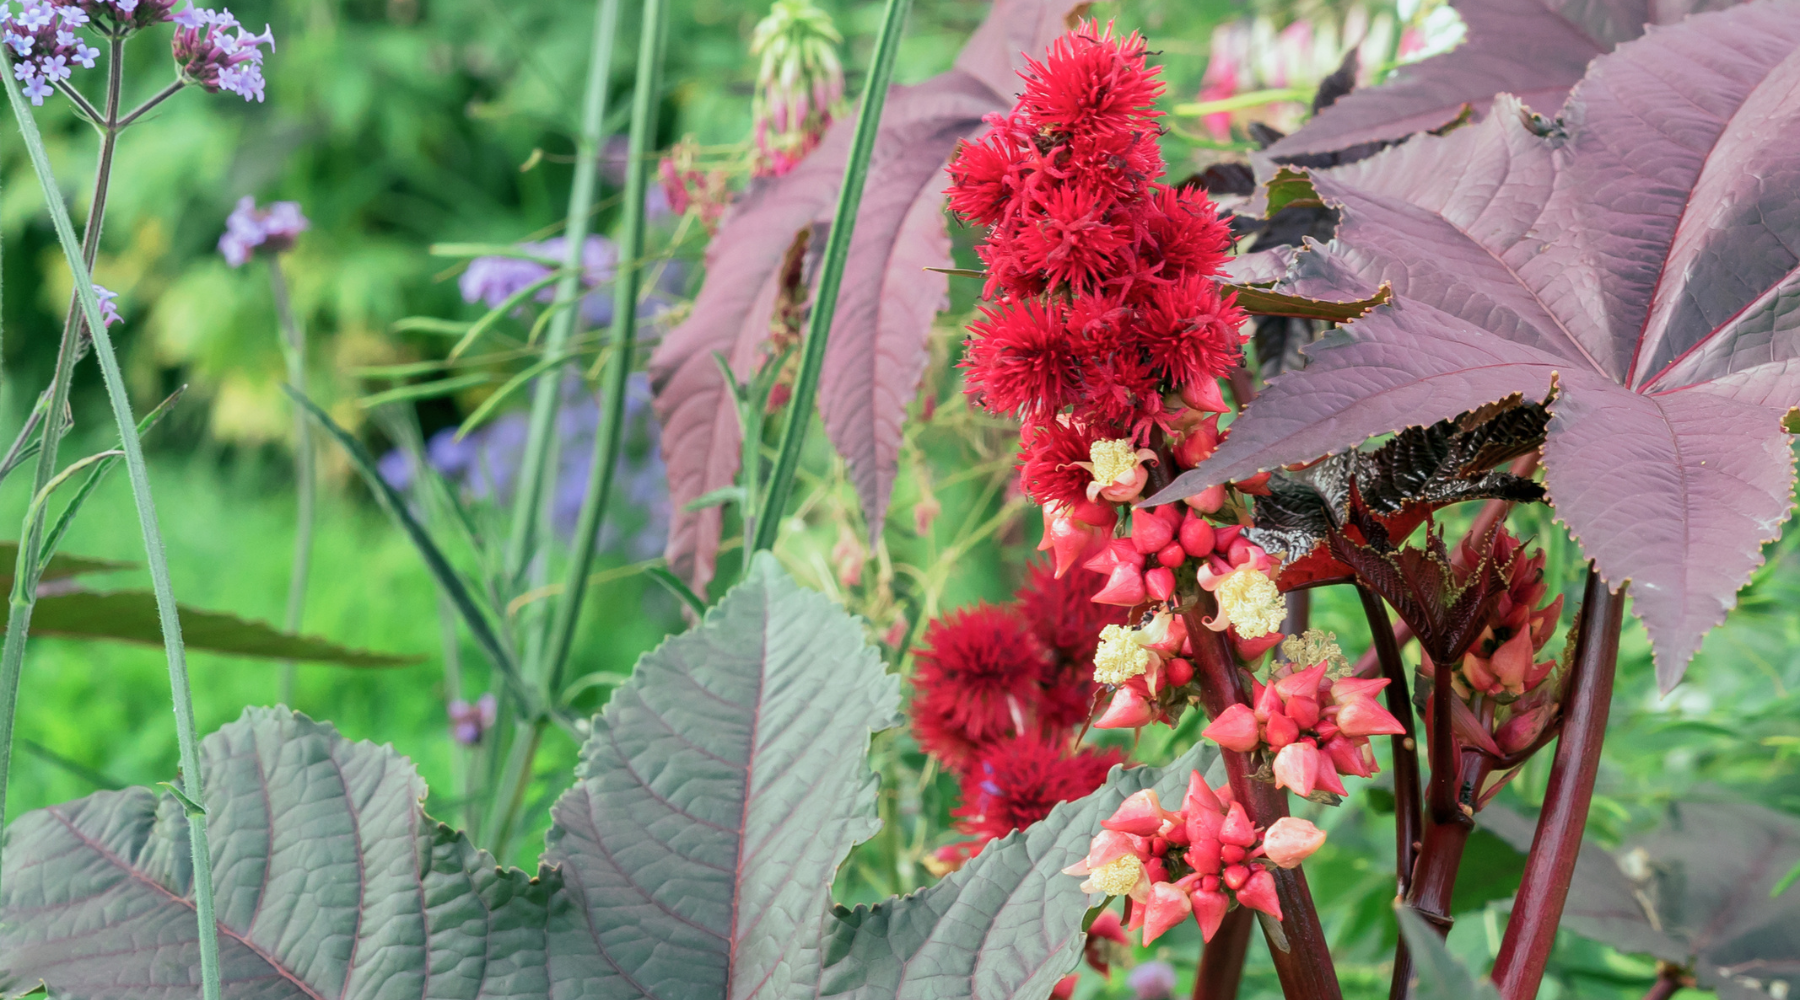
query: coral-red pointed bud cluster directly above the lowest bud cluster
[{"left": 1201, "top": 664, "right": 1406, "bottom": 795}]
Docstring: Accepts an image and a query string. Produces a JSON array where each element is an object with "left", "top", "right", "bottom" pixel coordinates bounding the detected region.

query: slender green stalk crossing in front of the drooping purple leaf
[{"left": 743, "top": 0, "right": 913, "bottom": 561}]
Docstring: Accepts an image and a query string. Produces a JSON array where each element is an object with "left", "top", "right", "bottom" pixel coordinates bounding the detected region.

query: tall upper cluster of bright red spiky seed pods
[{"left": 949, "top": 23, "right": 1244, "bottom": 482}]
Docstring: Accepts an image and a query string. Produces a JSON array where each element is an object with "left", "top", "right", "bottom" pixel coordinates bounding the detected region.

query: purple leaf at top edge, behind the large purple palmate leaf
[{"left": 1267, "top": 0, "right": 1737, "bottom": 162}]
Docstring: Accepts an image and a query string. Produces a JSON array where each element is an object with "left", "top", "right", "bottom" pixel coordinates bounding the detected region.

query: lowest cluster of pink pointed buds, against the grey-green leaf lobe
[{"left": 1064, "top": 772, "right": 1325, "bottom": 946}]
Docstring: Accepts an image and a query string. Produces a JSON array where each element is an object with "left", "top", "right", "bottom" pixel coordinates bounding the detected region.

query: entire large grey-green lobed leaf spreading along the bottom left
[{"left": 0, "top": 552, "right": 1215, "bottom": 1000}]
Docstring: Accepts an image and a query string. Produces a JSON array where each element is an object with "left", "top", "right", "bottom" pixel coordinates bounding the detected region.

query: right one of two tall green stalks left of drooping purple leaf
[{"left": 544, "top": 0, "right": 668, "bottom": 690}]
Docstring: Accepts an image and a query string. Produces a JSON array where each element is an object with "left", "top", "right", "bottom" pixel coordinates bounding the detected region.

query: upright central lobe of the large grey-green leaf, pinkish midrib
[{"left": 545, "top": 554, "right": 900, "bottom": 998}]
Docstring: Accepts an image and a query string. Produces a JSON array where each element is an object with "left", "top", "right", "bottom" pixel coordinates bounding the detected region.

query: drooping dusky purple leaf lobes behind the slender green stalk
[{"left": 650, "top": 0, "right": 1075, "bottom": 590}]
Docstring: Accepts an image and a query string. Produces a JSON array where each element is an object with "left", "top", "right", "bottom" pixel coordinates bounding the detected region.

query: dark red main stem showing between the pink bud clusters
[{"left": 1184, "top": 592, "right": 1343, "bottom": 1000}]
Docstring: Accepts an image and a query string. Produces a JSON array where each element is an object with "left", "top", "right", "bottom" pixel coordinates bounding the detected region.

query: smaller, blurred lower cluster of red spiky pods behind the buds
[{"left": 911, "top": 567, "right": 1125, "bottom": 863}]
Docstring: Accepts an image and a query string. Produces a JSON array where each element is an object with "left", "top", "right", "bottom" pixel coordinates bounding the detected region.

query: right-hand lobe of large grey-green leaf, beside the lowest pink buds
[{"left": 819, "top": 743, "right": 1216, "bottom": 1000}]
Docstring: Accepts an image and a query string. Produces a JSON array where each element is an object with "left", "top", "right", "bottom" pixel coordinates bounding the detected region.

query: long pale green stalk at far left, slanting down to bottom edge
[{"left": 0, "top": 54, "right": 220, "bottom": 1000}]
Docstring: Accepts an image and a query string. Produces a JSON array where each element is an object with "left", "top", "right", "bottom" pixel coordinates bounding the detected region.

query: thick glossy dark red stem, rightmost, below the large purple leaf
[{"left": 1494, "top": 565, "right": 1625, "bottom": 1000}]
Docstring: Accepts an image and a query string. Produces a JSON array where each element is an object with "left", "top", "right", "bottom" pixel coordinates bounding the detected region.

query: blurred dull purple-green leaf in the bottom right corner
[{"left": 1481, "top": 802, "right": 1800, "bottom": 1000}]
